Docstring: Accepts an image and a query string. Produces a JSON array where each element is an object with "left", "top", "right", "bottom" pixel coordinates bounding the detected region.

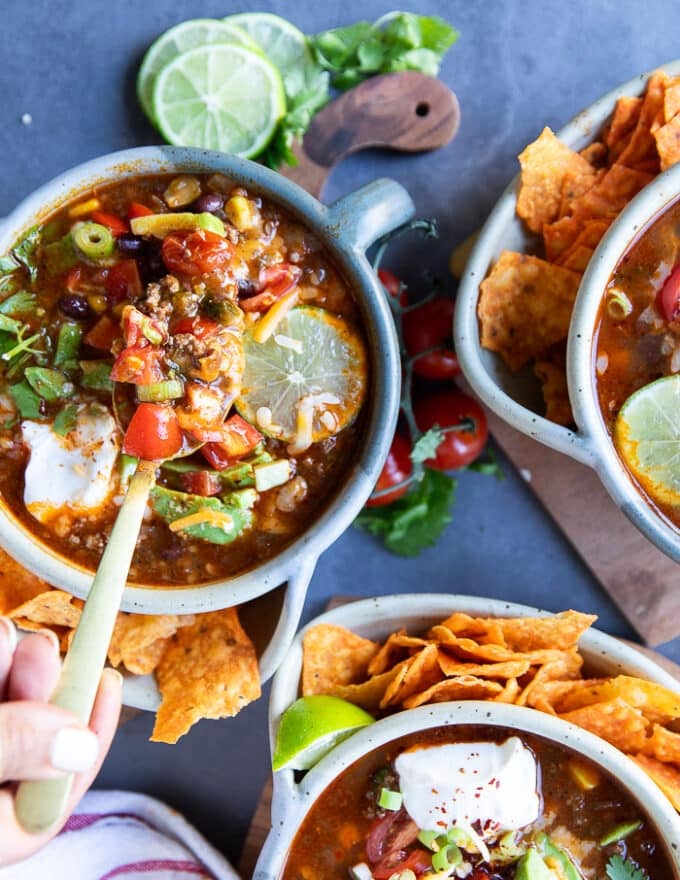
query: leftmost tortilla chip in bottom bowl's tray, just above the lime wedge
[{"left": 302, "top": 623, "right": 378, "bottom": 697}]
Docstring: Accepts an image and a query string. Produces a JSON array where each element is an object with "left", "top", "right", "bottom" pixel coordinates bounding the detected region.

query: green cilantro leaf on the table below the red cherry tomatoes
[{"left": 355, "top": 468, "right": 456, "bottom": 556}]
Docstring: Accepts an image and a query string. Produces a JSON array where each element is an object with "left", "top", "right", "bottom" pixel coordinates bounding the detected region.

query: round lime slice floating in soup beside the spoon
[{"left": 236, "top": 306, "right": 368, "bottom": 443}]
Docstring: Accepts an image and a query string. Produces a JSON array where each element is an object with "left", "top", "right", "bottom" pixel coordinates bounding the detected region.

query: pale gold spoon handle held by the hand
[{"left": 15, "top": 461, "right": 157, "bottom": 834}]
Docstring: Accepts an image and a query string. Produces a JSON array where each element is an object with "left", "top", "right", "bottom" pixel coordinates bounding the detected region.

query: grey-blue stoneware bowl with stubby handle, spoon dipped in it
[{"left": 0, "top": 147, "right": 414, "bottom": 688}]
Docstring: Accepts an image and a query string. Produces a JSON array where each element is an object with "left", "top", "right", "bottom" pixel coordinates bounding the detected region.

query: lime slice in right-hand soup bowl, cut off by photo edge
[{"left": 614, "top": 376, "right": 680, "bottom": 504}]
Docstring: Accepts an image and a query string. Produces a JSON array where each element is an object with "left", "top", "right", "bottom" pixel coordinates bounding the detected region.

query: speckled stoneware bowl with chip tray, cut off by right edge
[{"left": 454, "top": 61, "right": 680, "bottom": 561}]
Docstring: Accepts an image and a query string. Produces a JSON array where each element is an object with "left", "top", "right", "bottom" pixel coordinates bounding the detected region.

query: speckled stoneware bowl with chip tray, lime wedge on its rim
[{"left": 253, "top": 593, "right": 680, "bottom": 880}]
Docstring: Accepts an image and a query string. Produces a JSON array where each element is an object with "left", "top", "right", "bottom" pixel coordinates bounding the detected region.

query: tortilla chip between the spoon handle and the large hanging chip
[{"left": 109, "top": 612, "right": 196, "bottom": 675}]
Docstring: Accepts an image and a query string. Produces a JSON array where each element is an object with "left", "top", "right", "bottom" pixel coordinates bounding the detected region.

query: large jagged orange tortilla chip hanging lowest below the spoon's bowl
[{"left": 151, "top": 608, "right": 260, "bottom": 743}]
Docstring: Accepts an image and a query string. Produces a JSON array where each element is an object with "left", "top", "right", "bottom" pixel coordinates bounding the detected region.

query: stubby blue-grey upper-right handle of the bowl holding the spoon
[{"left": 324, "top": 177, "right": 415, "bottom": 251}]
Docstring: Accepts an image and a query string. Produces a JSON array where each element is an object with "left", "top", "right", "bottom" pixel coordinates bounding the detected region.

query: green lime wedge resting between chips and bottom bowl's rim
[{"left": 272, "top": 695, "right": 375, "bottom": 770}]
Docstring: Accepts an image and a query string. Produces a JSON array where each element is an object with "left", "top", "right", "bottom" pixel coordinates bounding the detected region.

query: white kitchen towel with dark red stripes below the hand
[{"left": 0, "top": 791, "right": 238, "bottom": 880}]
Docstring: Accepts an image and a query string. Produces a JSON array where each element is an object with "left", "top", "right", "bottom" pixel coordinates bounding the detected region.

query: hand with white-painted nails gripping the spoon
[{"left": 0, "top": 617, "right": 122, "bottom": 868}]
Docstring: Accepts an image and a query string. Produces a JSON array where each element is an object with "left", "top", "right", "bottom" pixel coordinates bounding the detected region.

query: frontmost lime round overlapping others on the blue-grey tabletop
[{"left": 153, "top": 43, "right": 286, "bottom": 158}]
